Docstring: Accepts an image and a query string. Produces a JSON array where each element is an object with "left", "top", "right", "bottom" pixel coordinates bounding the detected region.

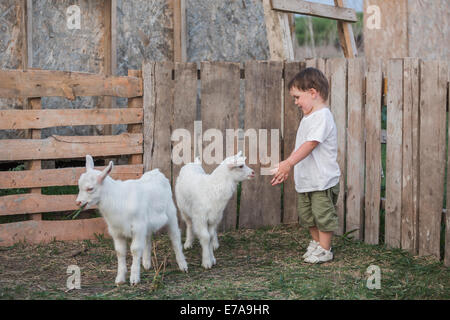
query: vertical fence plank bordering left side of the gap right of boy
[{"left": 364, "top": 63, "right": 383, "bottom": 244}]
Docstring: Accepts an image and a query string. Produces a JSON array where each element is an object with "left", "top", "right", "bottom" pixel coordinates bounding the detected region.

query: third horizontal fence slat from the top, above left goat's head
[{"left": 0, "top": 133, "right": 143, "bottom": 161}]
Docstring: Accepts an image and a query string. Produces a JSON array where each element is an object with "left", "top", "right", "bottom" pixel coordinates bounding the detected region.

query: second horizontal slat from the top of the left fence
[{"left": 0, "top": 108, "right": 143, "bottom": 130}]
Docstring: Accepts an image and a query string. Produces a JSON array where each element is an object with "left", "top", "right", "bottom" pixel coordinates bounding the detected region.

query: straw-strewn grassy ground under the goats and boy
[{"left": 0, "top": 225, "right": 450, "bottom": 300}]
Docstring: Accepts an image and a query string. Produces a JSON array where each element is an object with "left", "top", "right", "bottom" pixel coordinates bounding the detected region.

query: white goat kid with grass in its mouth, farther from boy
[{"left": 76, "top": 155, "right": 188, "bottom": 285}]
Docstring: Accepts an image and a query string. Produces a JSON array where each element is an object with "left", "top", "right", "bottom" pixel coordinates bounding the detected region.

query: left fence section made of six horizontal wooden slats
[{"left": 0, "top": 70, "right": 143, "bottom": 246}]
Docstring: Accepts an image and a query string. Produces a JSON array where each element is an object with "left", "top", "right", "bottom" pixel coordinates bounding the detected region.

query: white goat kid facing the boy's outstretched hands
[{"left": 175, "top": 152, "right": 255, "bottom": 269}]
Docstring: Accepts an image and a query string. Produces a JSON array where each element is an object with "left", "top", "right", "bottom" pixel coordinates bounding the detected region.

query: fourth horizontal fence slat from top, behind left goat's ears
[{"left": 0, "top": 164, "right": 144, "bottom": 189}]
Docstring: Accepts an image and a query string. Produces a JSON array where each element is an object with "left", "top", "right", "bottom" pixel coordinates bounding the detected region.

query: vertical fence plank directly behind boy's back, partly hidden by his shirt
[{"left": 328, "top": 58, "right": 347, "bottom": 235}]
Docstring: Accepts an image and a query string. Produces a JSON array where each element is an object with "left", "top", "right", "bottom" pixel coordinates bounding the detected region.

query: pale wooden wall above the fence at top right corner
[{"left": 364, "top": 0, "right": 450, "bottom": 67}]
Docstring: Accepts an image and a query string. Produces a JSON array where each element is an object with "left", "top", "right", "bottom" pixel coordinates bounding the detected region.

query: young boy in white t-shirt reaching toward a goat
[{"left": 271, "top": 68, "right": 341, "bottom": 263}]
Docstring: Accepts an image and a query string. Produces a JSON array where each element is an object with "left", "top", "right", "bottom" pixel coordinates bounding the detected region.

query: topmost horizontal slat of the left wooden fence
[{"left": 0, "top": 70, "right": 142, "bottom": 100}]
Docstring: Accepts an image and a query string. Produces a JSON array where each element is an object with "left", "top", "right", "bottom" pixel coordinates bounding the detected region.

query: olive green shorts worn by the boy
[{"left": 297, "top": 183, "right": 339, "bottom": 232}]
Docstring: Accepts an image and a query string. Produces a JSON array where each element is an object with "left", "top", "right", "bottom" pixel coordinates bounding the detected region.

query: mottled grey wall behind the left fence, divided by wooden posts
[{"left": 0, "top": 0, "right": 269, "bottom": 138}]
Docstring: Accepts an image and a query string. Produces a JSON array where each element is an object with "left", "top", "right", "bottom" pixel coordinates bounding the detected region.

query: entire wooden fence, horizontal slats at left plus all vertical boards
[{"left": 0, "top": 58, "right": 450, "bottom": 265}]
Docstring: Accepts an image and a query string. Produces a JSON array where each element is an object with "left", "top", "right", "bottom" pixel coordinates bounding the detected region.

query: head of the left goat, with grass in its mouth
[{"left": 76, "top": 155, "right": 113, "bottom": 209}]
